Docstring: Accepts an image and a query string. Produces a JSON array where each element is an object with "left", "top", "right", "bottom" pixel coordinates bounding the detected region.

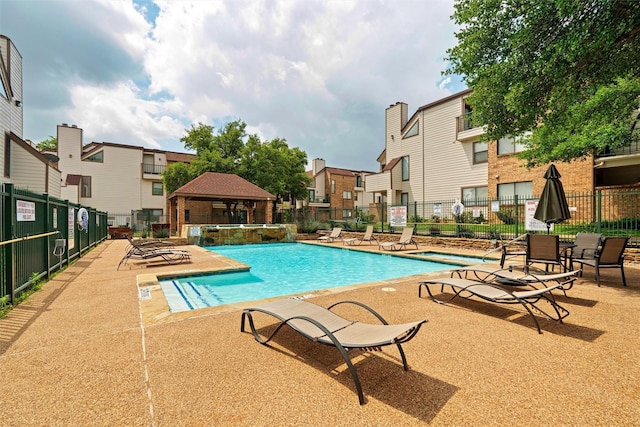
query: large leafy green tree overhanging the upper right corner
[{"left": 445, "top": 0, "right": 640, "bottom": 166}]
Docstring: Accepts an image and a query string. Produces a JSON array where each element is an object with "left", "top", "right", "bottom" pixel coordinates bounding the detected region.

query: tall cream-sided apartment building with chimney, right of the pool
[{"left": 365, "top": 90, "right": 488, "bottom": 216}]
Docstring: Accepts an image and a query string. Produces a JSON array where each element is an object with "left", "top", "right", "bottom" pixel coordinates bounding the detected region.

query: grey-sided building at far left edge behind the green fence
[{"left": 0, "top": 35, "right": 61, "bottom": 198}]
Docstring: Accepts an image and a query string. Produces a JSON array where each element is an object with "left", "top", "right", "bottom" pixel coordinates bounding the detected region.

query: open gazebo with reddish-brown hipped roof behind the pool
[{"left": 167, "top": 172, "right": 276, "bottom": 233}]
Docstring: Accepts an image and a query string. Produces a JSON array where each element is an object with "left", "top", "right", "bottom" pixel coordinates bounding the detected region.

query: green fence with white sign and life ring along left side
[{"left": 0, "top": 184, "right": 107, "bottom": 304}]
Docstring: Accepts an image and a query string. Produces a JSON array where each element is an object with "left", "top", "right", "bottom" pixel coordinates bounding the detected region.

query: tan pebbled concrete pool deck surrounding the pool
[{"left": 0, "top": 240, "right": 640, "bottom": 426}]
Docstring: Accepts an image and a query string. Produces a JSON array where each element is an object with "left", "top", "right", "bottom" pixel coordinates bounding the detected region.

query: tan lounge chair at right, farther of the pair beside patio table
[{"left": 451, "top": 265, "right": 580, "bottom": 296}]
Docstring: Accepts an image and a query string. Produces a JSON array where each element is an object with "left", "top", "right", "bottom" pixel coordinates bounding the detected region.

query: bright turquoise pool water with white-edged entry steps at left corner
[{"left": 160, "top": 243, "right": 451, "bottom": 312}]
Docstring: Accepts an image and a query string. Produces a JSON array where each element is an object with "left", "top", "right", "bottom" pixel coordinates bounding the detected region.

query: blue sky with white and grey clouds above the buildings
[{"left": 0, "top": 0, "right": 465, "bottom": 171}]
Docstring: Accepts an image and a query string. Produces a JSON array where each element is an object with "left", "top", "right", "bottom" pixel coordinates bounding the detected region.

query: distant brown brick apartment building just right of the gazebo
[{"left": 298, "top": 158, "right": 373, "bottom": 221}]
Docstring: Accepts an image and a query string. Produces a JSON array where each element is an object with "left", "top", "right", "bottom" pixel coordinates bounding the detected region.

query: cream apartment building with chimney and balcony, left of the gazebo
[{"left": 56, "top": 123, "right": 195, "bottom": 225}]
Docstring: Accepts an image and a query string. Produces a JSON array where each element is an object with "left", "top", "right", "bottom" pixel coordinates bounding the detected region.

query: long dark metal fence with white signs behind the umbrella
[{"left": 295, "top": 188, "right": 640, "bottom": 246}]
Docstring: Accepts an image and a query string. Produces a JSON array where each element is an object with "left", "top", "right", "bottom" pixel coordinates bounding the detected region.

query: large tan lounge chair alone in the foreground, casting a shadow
[{"left": 240, "top": 299, "right": 427, "bottom": 405}]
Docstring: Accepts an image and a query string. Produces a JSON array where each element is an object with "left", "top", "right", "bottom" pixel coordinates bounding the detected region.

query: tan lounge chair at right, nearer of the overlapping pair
[{"left": 418, "top": 277, "right": 569, "bottom": 334}]
